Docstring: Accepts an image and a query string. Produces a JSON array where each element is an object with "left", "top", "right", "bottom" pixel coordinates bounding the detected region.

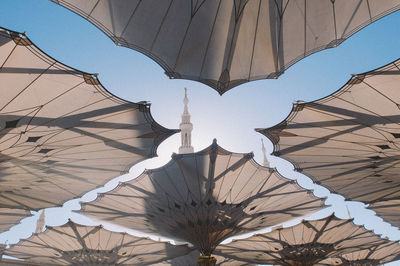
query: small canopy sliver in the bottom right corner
[{"left": 316, "top": 240, "right": 400, "bottom": 266}]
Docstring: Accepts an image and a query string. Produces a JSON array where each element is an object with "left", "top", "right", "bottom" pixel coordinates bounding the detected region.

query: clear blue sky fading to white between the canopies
[{"left": 0, "top": 0, "right": 400, "bottom": 265}]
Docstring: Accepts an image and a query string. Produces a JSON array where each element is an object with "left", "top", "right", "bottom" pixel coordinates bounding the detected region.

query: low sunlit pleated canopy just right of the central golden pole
[{"left": 215, "top": 214, "right": 387, "bottom": 266}]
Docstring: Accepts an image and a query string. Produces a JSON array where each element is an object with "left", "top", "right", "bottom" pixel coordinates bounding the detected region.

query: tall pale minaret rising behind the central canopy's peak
[{"left": 179, "top": 88, "right": 194, "bottom": 153}]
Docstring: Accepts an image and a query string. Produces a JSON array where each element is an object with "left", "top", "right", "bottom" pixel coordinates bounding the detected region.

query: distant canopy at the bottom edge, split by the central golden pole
[{"left": 153, "top": 250, "right": 255, "bottom": 266}]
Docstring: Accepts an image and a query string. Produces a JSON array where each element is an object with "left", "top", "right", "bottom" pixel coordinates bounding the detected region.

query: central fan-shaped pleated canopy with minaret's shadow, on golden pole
[{"left": 81, "top": 141, "right": 324, "bottom": 255}]
